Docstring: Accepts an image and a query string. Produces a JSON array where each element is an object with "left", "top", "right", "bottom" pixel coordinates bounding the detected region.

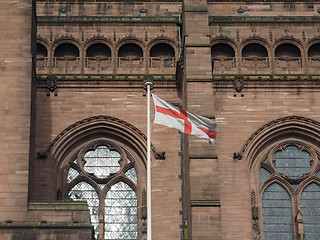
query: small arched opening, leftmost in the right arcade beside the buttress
[{"left": 211, "top": 43, "right": 236, "bottom": 73}]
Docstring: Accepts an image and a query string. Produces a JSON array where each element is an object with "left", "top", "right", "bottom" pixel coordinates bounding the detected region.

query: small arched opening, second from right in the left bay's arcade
[{"left": 118, "top": 43, "right": 143, "bottom": 68}]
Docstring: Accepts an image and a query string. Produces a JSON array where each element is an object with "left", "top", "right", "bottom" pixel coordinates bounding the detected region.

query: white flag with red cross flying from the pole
[{"left": 152, "top": 94, "right": 217, "bottom": 143}]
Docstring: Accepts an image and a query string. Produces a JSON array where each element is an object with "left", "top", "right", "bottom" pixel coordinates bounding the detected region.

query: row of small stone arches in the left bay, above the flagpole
[{"left": 37, "top": 39, "right": 177, "bottom": 74}]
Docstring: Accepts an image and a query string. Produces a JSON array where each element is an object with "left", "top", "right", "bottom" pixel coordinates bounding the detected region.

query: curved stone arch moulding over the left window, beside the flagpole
[{"left": 47, "top": 115, "right": 165, "bottom": 170}]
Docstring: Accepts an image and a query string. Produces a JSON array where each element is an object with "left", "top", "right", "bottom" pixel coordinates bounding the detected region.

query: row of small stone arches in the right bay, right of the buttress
[{"left": 211, "top": 39, "right": 320, "bottom": 74}]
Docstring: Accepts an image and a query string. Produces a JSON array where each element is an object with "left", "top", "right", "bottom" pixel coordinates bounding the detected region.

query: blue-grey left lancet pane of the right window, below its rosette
[{"left": 262, "top": 183, "right": 293, "bottom": 240}]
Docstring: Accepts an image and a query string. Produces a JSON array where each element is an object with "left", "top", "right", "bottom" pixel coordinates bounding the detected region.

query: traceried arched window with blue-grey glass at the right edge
[{"left": 255, "top": 141, "right": 320, "bottom": 240}]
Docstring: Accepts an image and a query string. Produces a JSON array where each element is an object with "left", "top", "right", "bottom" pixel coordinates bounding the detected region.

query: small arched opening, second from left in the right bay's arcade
[{"left": 241, "top": 43, "right": 269, "bottom": 71}]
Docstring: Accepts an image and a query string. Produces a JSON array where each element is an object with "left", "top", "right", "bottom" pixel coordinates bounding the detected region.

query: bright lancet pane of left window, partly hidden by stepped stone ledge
[{"left": 67, "top": 182, "right": 99, "bottom": 238}]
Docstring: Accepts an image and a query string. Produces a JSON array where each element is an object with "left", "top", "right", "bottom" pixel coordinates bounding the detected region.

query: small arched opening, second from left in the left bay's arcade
[{"left": 53, "top": 43, "right": 80, "bottom": 73}]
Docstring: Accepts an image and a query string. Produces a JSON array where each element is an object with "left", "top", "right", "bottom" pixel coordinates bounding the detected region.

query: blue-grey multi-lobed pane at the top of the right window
[{"left": 274, "top": 146, "right": 311, "bottom": 178}]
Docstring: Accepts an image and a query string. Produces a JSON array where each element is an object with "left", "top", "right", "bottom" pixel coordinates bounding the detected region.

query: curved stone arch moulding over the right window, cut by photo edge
[{"left": 234, "top": 116, "right": 320, "bottom": 168}]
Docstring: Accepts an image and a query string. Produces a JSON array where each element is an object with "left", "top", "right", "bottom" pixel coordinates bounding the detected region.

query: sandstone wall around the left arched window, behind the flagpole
[{"left": 35, "top": 86, "right": 181, "bottom": 239}]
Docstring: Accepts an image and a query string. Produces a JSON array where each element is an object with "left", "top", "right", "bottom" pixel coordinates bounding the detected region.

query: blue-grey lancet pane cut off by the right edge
[{"left": 301, "top": 183, "right": 320, "bottom": 240}]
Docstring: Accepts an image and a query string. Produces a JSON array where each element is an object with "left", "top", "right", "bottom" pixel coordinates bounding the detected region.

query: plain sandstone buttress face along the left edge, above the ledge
[{"left": 0, "top": 0, "right": 31, "bottom": 221}]
